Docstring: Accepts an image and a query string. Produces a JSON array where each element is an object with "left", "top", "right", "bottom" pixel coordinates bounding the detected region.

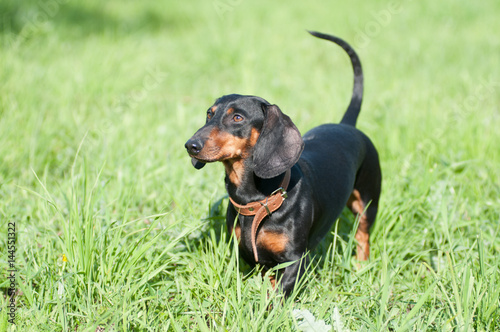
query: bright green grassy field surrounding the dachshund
[{"left": 0, "top": 0, "right": 500, "bottom": 331}]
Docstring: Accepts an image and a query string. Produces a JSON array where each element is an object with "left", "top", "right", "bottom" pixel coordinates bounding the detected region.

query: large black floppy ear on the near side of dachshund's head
[{"left": 253, "top": 104, "right": 304, "bottom": 179}]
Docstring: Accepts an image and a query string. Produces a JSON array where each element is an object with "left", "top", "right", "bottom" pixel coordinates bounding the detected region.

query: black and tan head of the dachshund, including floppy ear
[{"left": 185, "top": 94, "right": 304, "bottom": 179}]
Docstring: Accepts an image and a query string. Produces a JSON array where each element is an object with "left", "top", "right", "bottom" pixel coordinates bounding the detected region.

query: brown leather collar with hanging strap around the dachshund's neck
[{"left": 229, "top": 169, "right": 292, "bottom": 262}]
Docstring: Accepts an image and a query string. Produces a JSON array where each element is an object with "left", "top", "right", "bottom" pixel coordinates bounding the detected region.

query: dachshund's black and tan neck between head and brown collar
[{"left": 223, "top": 159, "right": 285, "bottom": 204}]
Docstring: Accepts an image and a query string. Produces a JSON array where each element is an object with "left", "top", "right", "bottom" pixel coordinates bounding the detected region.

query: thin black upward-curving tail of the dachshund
[{"left": 308, "top": 31, "right": 363, "bottom": 126}]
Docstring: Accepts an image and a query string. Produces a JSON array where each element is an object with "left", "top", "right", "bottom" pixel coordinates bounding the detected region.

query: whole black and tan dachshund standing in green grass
[{"left": 185, "top": 32, "right": 382, "bottom": 295}]
